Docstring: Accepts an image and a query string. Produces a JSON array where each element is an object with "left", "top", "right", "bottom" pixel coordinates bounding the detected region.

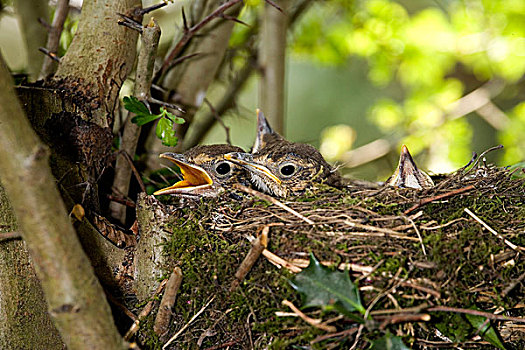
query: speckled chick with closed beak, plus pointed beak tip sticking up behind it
[{"left": 224, "top": 110, "right": 341, "bottom": 197}]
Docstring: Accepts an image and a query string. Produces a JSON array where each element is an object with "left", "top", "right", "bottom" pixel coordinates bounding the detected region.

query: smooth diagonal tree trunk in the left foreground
[{"left": 0, "top": 54, "right": 124, "bottom": 349}]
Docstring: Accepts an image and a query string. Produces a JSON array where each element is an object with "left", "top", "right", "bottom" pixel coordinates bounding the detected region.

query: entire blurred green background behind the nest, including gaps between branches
[{"left": 0, "top": 0, "right": 525, "bottom": 180}]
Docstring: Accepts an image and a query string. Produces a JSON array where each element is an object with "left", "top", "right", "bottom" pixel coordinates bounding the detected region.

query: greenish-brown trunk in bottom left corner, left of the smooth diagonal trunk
[{"left": 0, "top": 185, "right": 64, "bottom": 350}]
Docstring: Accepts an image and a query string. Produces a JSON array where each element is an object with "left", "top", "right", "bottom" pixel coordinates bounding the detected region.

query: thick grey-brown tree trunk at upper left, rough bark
[{"left": 54, "top": 0, "right": 142, "bottom": 128}]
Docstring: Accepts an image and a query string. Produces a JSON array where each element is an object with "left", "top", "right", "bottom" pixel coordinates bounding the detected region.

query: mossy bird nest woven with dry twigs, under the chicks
[{"left": 139, "top": 165, "right": 525, "bottom": 349}]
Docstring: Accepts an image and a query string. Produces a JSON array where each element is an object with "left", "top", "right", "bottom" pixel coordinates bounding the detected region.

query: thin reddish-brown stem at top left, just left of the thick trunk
[{"left": 38, "top": 0, "right": 69, "bottom": 79}]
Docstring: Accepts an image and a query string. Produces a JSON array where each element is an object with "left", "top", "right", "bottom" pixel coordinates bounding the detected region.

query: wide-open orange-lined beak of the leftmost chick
[{"left": 153, "top": 153, "right": 213, "bottom": 196}]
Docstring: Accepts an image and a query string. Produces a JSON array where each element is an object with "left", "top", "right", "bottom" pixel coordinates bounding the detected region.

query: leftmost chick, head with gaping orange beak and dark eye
[{"left": 153, "top": 145, "right": 249, "bottom": 198}]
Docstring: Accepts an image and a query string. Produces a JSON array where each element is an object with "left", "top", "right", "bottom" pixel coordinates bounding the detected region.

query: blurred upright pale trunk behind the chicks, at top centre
[{"left": 259, "top": 0, "right": 289, "bottom": 135}]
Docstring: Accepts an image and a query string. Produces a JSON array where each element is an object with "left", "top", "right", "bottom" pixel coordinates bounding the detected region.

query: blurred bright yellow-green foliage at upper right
[{"left": 291, "top": 0, "right": 525, "bottom": 170}]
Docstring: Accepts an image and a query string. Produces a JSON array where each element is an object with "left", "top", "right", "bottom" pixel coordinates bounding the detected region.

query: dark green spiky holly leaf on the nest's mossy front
[{"left": 290, "top": 254, "right": 366, "bottom": 314}]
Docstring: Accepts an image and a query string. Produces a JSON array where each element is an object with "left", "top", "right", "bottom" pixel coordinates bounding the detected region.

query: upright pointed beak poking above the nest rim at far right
[{"left": 385, "top": 145, "right": 434, "bottom": 190}]
